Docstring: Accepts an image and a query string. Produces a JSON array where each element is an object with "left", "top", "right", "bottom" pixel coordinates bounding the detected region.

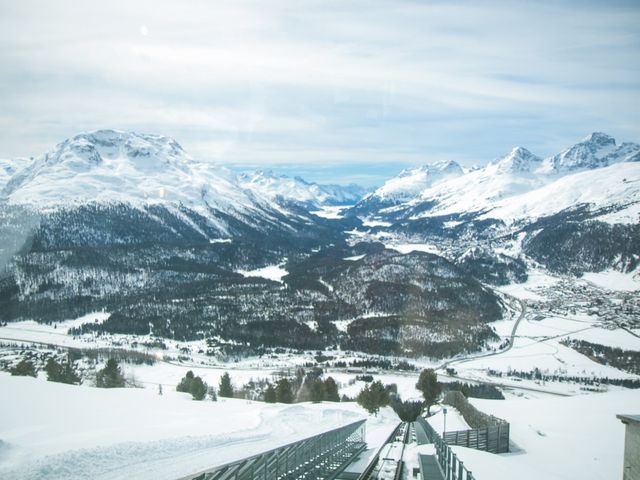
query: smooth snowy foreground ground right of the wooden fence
[{"left": 453, "top": 390, "right": 640, "bottom": 480}]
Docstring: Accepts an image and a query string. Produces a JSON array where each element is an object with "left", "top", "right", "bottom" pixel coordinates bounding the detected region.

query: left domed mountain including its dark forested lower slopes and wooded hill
[{"left": 0, "top": 130, "right": 503, "bottom": 356}]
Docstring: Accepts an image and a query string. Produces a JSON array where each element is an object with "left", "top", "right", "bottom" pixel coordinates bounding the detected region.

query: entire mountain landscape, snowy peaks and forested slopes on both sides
[{"left": 0, "top": 130, "right": 640, "bottom": 358}]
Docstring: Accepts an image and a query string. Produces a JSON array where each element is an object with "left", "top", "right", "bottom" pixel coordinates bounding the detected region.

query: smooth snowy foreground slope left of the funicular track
[{"left": 0, "top": 372, "right": 398, "bottom": 480}]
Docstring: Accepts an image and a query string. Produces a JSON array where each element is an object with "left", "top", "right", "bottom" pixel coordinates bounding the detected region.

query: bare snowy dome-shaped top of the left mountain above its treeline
[{"left": 2, "top": 130, "right": 272, "bottom": 215}]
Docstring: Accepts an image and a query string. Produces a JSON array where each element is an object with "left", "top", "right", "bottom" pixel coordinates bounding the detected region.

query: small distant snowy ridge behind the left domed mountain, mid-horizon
[{"left": 239, "top": 170, "right": 366, "bottom": 207}]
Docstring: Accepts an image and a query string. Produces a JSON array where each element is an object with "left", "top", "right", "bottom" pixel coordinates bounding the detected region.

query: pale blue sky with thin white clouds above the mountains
[{"left": 0, "top": 0, "right": 640, "bottom": 184}]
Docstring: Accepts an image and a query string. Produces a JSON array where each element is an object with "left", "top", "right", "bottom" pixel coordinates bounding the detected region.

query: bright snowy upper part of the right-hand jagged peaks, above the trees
[{"left": 356, "top": 133, "right": 640, "bottom": 221}]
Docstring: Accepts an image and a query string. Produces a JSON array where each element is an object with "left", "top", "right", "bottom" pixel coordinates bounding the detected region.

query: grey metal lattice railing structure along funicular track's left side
[{"left": 180, "top": 420, "right": 366, "bottom": 480}]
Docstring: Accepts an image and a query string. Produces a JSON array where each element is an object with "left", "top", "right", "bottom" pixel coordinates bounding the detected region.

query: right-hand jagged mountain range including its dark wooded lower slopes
[{"left": 349, "top": 133, "right": 640, "bottom": 274}]
